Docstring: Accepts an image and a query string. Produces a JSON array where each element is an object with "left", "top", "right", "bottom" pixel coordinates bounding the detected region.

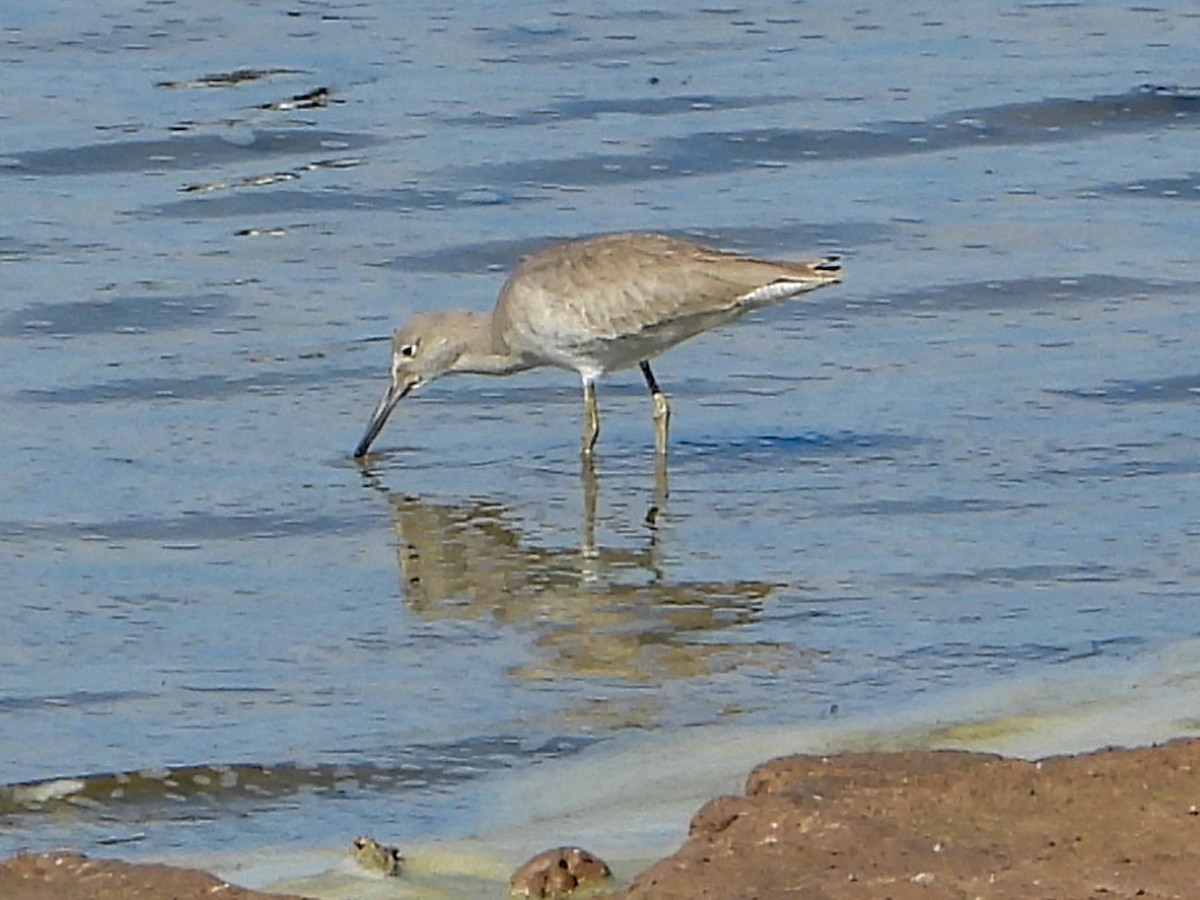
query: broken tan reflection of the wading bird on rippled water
[{"left": 355, "top": 466, "right": 805, "bottom": 720}]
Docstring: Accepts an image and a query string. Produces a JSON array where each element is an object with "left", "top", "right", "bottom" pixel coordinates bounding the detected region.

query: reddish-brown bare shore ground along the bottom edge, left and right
[{"left": 9, "top": 739, "right": 1200, "bottom": 900}]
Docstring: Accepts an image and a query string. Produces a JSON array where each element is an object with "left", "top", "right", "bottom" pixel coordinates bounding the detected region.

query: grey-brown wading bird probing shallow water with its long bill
[{"left": 354, "top": 233, "right": 841, "bottom": 457}]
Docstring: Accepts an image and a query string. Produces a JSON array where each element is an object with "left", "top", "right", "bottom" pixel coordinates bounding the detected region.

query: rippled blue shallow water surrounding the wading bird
[{"left": 0, "top": 1, "right": 1200, "bottom": 873}]
